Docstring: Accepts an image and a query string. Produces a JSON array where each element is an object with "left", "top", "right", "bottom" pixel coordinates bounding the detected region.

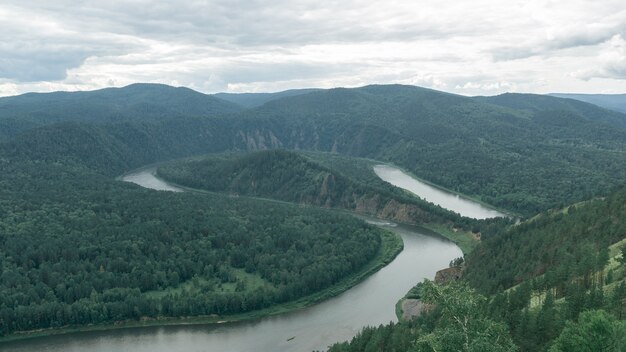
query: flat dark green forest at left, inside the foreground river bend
[{"left": 0, "top": 157, "right": 381, "bottom": 334}]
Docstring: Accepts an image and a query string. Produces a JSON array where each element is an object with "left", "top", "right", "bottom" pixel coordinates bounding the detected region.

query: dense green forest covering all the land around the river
[{"left": 0, "top": 84, "right": 626, "bottom": 351}]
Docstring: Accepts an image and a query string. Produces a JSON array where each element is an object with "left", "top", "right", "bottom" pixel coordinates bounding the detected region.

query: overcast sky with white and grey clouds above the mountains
[{"left": 0, "top": 0, "right": 626, "bottom": 96}]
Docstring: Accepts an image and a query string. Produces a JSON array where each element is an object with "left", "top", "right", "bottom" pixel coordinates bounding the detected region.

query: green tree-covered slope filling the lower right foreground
[{"left": 330, "top": 190, "right": 626, "bottom": 352}]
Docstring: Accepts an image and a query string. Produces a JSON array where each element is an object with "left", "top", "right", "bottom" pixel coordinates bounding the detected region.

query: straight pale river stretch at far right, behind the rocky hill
[{"left": 374, "top": 165, "right": 507, "bottom": 219}]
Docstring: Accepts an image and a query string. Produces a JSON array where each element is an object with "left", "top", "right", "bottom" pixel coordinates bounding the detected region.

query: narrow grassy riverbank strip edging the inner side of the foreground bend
[{"left": 0, "top": 231, "right": 404, "bottom": 343}]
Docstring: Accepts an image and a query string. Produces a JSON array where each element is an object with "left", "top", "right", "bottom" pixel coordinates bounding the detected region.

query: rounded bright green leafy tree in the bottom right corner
[{"left": 550, "top": 310, "right": 626, "bottom": 352}]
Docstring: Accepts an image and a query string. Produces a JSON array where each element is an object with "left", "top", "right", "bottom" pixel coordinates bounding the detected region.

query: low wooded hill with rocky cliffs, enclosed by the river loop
[{"left": 157, "top": 150, "right": 487, "bottom": 241}]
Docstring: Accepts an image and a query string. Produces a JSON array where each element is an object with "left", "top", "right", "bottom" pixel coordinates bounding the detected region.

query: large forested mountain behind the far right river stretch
[{"left": 243, "top": 85, "right": 626, "bottom": 215}]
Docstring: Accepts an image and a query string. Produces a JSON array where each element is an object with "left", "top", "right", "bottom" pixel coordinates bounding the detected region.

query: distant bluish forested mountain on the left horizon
[{"left": 0, "top": 84, "right": 241, "bottom": 136}]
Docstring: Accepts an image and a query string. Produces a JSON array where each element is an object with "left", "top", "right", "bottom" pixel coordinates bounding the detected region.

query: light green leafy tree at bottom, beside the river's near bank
[{"left": 416, "top": 280, "right": 517, "bottom": 352}]
